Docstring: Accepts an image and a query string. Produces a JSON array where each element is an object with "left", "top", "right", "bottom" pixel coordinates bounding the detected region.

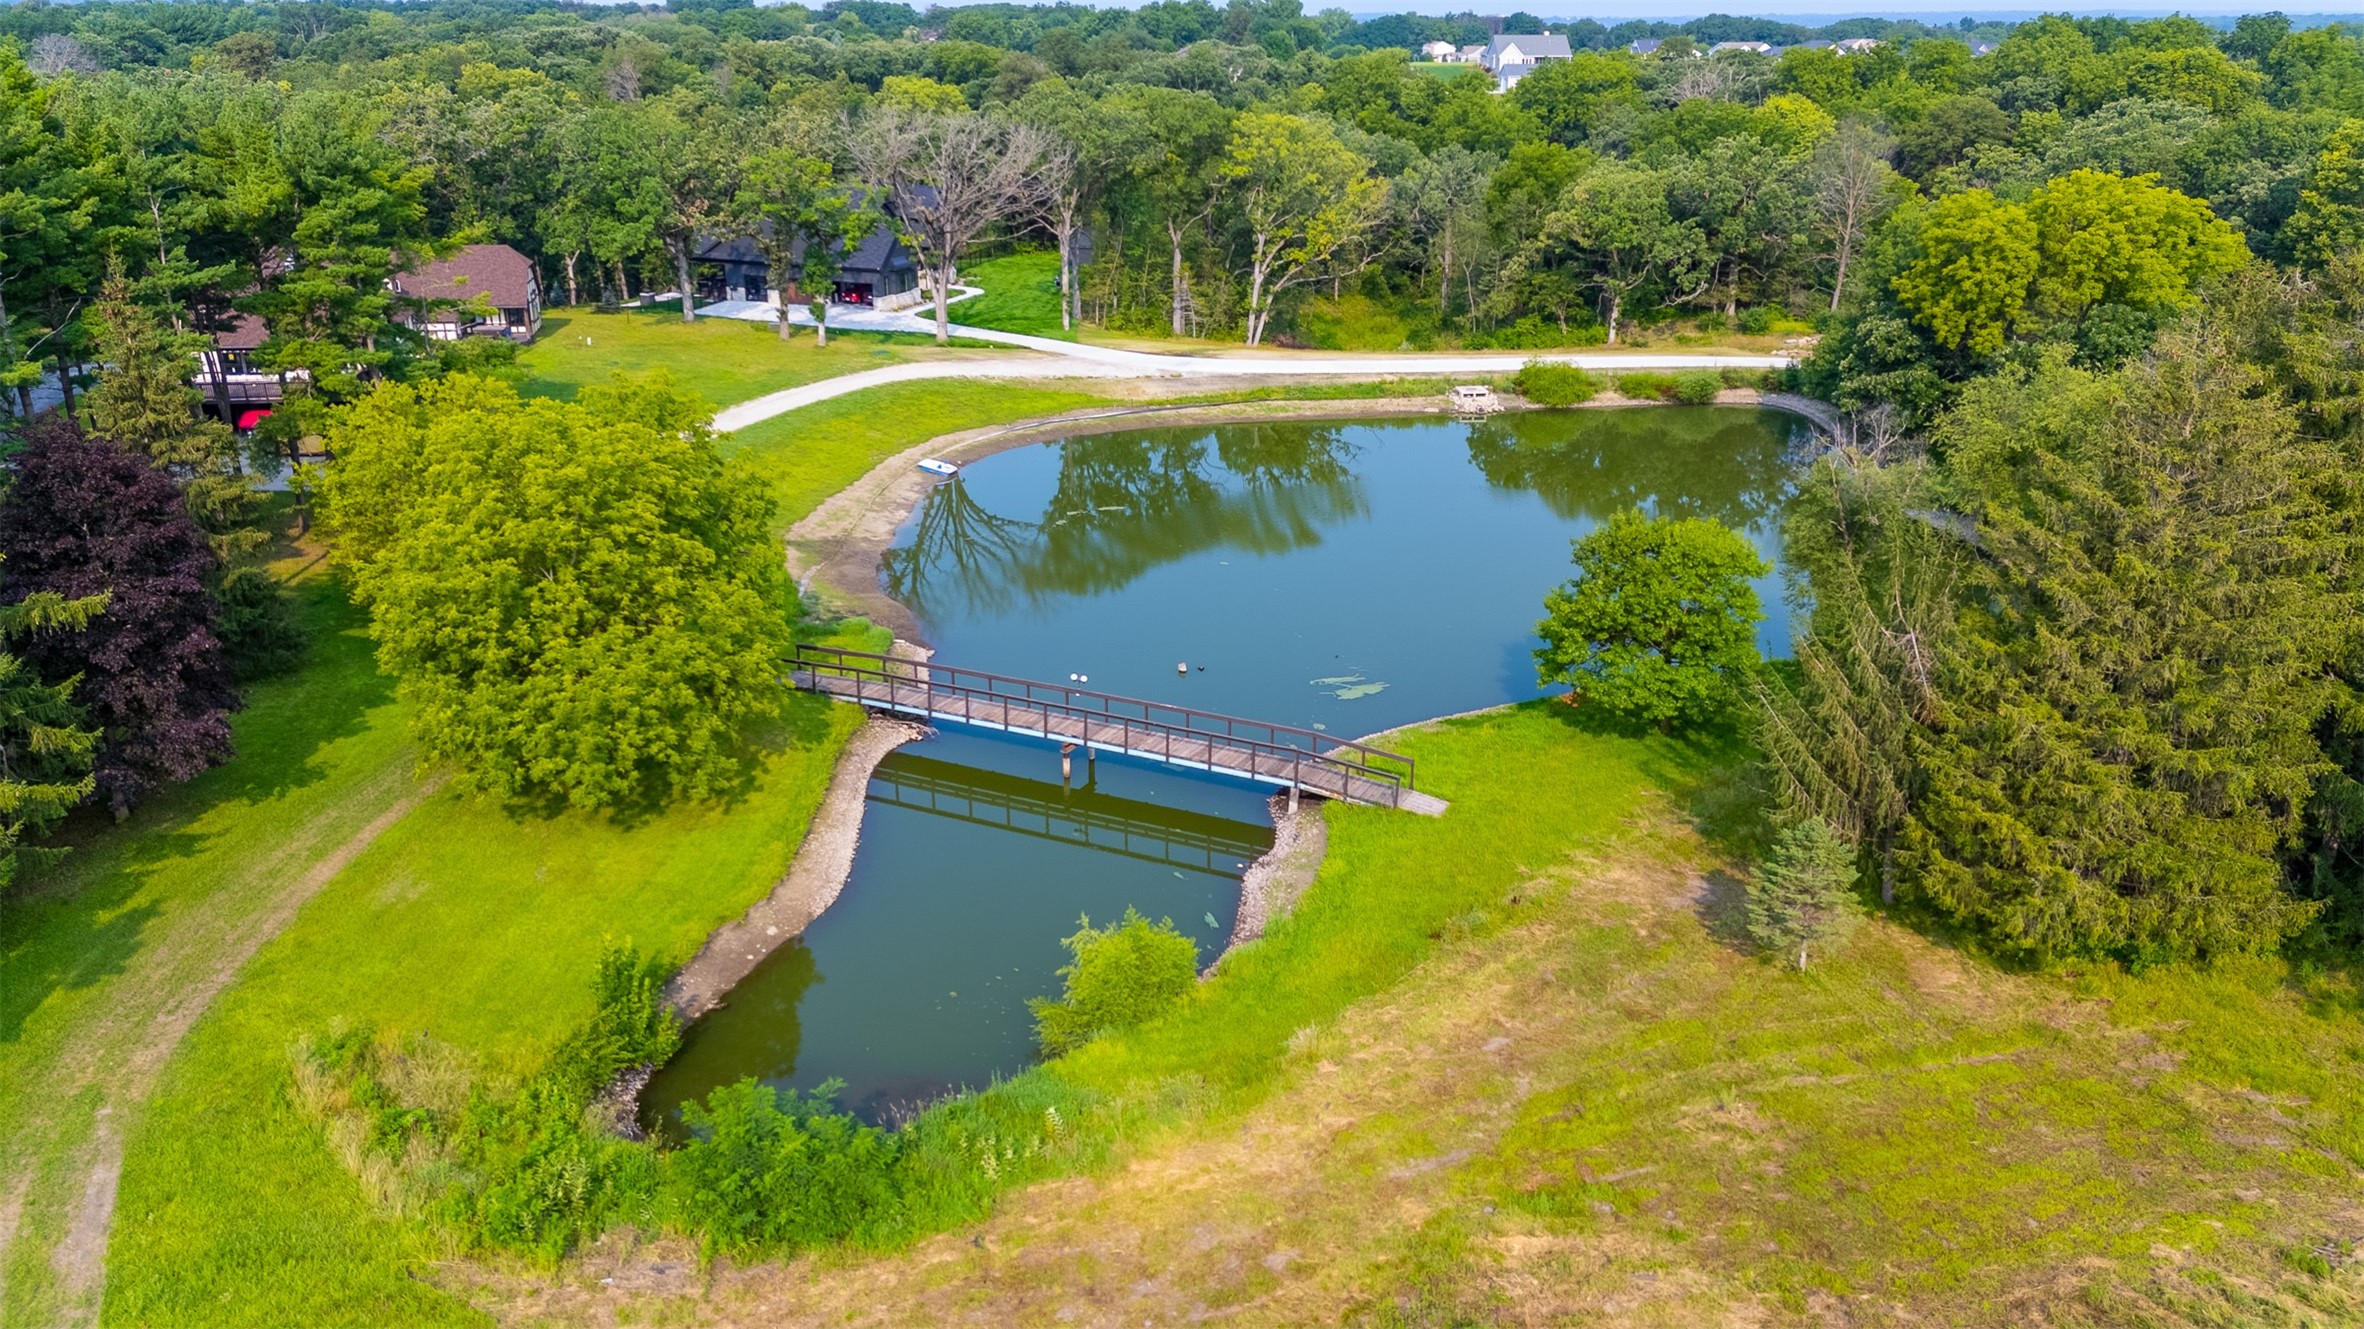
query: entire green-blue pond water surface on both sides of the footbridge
[{"left": 643, "top": 407, "right": 1806, "bottom": 1126}]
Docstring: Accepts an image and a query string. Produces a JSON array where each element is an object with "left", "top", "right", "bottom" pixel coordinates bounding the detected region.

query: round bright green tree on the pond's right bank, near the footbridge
[{"left": 1534, "top": 511, "right": 1768, "bottom": 728}]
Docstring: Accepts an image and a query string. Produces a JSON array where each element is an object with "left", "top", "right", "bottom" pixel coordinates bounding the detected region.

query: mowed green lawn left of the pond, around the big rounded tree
[{"left": 0, "top": 366, "right": 1120, "bottom": 1324}]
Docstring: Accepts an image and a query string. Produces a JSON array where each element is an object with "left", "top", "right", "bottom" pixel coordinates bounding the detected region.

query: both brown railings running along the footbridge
[{"left": 790, "top": 646, "right": 1414, "bottom": 806}]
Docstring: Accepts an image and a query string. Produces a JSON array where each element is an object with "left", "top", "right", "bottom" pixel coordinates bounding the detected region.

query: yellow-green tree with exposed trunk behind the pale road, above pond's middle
[{"left": 1215, "top": 111, "right": 1388, "bottom": 345}]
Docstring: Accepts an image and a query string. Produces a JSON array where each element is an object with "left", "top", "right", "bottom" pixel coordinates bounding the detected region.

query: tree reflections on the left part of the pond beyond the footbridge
[{"left": 879, "top": 423, "right": 1366, "bottom": 620}]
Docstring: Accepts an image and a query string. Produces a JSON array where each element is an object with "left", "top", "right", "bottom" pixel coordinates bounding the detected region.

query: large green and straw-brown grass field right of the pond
[{"left": 543, "top": 702, "right": 2364, "bottom": 1329}]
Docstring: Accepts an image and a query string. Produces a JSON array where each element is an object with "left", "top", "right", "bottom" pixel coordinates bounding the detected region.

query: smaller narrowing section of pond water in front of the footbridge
[{"left": 641, "top": 733, "right": 1272, "bottom": 1130}]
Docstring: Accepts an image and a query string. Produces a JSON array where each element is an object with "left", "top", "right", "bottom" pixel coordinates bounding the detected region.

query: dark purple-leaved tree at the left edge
[{"left": 0, "top": 421, "right": 239, "bottom": 816}]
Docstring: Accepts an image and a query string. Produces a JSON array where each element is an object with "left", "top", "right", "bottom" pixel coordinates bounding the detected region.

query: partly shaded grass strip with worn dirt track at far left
[{"left": 0, "top": 570, "right": 416, "bottom": 1324}]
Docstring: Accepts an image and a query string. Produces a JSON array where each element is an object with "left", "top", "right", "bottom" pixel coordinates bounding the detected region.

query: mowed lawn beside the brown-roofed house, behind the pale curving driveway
[{"left": 518, "top": 307, "right": 931, "bottom": 407}]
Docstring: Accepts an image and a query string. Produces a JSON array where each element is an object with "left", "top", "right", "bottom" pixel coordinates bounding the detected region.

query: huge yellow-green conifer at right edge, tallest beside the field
[{"left": 1901, "top": 322, "right": 2355, "bottom": 958}]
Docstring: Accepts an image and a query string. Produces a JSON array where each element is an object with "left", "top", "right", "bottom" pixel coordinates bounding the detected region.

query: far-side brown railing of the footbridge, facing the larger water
[{"left": 790, "top": 646, "right": 1414, "bottom": 802}]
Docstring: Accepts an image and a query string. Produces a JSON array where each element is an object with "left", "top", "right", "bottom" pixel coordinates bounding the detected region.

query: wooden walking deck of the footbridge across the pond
[{"left": 794, "top": 665, "right": 1447, "bottom": 816}]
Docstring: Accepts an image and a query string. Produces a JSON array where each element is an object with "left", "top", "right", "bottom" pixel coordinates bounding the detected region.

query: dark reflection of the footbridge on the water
[{"left": 870, "top": 752, "right": 1272, "bottom": 877}]
